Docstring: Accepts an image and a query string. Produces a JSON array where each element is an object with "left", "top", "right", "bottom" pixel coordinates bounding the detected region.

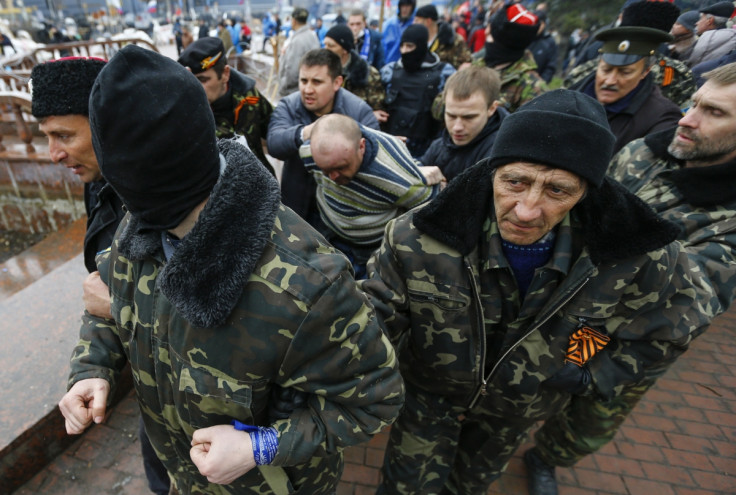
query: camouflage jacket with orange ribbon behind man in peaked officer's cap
[{"left": 564, "top": 53, "right": 697, "bottom": 108}]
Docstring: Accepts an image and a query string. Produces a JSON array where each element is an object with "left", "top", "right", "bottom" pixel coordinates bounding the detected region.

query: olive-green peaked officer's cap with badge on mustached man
[{"left": 595, "top": 26, "right": 673, "bottom": 67}]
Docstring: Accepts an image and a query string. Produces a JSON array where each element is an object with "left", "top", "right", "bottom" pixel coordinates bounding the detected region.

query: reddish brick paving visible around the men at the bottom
[{"left": 12, "top": 310, "right": 736, "bottom": 495}]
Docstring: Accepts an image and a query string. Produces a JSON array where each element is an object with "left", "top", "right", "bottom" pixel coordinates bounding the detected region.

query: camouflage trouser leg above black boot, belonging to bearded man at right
[{"left": 534, "top": 380, "right": 655, "bottom": 467}]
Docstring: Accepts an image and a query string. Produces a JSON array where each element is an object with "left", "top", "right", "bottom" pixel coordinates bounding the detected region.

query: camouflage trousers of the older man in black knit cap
[{"left": 377, "top": 384, "right": 535, "bottom": 495}]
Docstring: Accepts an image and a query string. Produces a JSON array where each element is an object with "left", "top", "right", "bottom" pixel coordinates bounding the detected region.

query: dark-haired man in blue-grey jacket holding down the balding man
[{"left": 268, "top": 48, "right": 378, "bottom": 225}]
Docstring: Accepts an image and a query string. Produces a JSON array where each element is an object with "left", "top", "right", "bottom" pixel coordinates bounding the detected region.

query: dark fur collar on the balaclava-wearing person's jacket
[{"left": 118, "top": 140, "right": 280, "bottom": 327}]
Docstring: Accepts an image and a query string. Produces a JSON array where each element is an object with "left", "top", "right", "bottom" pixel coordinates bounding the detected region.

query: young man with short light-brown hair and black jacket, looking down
[{"left": 420, "top": 65, "right": 508, "bottom": 181}]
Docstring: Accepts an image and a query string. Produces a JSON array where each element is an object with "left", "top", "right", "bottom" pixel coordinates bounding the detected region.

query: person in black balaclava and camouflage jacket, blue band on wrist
[{"left": 60, "top": 45, "right": 403, "bottom": 495}]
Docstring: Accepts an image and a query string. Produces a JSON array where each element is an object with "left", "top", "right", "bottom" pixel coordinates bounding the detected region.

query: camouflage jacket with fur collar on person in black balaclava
[{"left": 69, "top": 141, "right": 403, "bottom": 495}]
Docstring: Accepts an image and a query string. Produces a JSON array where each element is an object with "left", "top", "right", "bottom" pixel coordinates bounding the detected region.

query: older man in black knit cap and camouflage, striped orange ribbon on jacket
[{"left": 362, "top": 90, "right": 709, "bottom": 494}]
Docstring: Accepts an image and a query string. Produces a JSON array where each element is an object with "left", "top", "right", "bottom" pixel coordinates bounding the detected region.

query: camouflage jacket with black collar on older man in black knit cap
[{"left": 361, "top": 161, "right": 706, "bottom": 421}]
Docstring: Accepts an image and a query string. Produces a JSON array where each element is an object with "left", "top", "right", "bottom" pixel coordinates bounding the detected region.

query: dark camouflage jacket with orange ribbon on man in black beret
[{"left": 212, "top": 67, "right": 273, "bottom": 171}]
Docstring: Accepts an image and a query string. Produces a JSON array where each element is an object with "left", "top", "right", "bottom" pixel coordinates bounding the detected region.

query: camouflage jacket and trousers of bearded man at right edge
[{"left": 536, "top": 130, "right": 736, "bottom": 466}]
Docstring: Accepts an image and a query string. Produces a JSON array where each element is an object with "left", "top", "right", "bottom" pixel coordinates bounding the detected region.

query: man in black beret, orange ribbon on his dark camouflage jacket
[{"left": 179, "top": 37, "right": 274, "bottom": 178}]
